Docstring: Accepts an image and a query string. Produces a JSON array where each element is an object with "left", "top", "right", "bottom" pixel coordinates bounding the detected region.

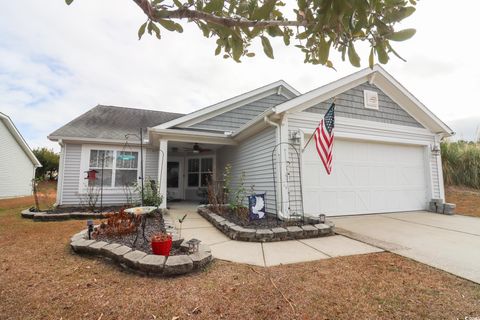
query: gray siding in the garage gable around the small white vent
[{"left": 305, "top": 82, "right": 423, "bottom": 128}]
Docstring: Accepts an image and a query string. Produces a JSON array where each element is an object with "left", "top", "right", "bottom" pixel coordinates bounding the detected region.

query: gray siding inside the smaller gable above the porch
[{"left": 190, "top": 94, "right": 288, "bottom": 132}]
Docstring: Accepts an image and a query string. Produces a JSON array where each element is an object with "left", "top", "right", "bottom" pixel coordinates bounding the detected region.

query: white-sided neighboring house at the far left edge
[{"left": 0, "top": 112, "right": 42, "bottom": 198}]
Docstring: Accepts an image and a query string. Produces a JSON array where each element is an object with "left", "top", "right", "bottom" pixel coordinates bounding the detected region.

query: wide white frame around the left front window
[{"left": 78, "top": 144, "right": 142, "bottom": 194}]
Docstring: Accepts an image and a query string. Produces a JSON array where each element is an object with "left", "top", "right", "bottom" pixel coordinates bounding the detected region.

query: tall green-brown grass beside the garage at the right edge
[{"left": 441, "top": 141, "right": 480, "bottom": 189}]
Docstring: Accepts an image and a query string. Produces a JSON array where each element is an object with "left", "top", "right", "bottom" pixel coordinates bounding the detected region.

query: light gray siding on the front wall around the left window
[{"left": 60, "top": 143, "right": 158, "bottom": 206}]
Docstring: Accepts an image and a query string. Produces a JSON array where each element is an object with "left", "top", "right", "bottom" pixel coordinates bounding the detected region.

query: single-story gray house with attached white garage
[{"left": 49, "top": 66, "right": 453, "bottom": 215}]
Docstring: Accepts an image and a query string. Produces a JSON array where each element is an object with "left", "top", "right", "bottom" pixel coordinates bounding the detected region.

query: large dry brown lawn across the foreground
[{"left": 0, "top": 188, "right": 480, "bottom": 320}]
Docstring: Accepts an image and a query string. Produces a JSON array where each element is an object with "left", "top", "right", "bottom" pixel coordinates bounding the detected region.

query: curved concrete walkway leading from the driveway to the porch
[{"left": 169, "top": 202, "right": 383, "bottom": 267}]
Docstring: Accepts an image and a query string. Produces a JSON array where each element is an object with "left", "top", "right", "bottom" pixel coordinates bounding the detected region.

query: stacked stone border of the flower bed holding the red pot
[{"left": 70, "top": 212, "right": 212, "bottom": 277}]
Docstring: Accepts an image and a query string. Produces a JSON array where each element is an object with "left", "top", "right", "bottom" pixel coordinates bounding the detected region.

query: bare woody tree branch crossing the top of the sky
[{"left": 133, "top": 0, "right": 308, "bottom": 28}]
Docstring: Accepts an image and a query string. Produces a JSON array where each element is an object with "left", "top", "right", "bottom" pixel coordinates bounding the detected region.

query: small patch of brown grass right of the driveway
[{"left": 445, "top": 186, "right": 480, "bottom": 217}]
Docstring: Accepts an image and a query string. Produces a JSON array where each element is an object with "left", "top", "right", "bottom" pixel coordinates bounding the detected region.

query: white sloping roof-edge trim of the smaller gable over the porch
[{"left": 155, "top": 80, "right": 300, "bottom": 129}]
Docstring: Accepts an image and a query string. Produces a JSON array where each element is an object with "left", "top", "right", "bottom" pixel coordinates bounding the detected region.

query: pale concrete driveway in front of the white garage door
[{"left": 332, "top": 211, "right": 480, "bottom": 283}]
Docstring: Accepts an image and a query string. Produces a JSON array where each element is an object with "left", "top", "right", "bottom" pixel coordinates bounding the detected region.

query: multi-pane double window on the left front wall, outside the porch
[{"left": 88, "top": 149, "right": 138, "bottom": 188}]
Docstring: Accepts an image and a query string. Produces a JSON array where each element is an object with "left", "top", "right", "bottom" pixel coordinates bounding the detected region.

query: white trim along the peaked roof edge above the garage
[{"left": 274, "top": 65, "right": 453, "bottom": 137}]
